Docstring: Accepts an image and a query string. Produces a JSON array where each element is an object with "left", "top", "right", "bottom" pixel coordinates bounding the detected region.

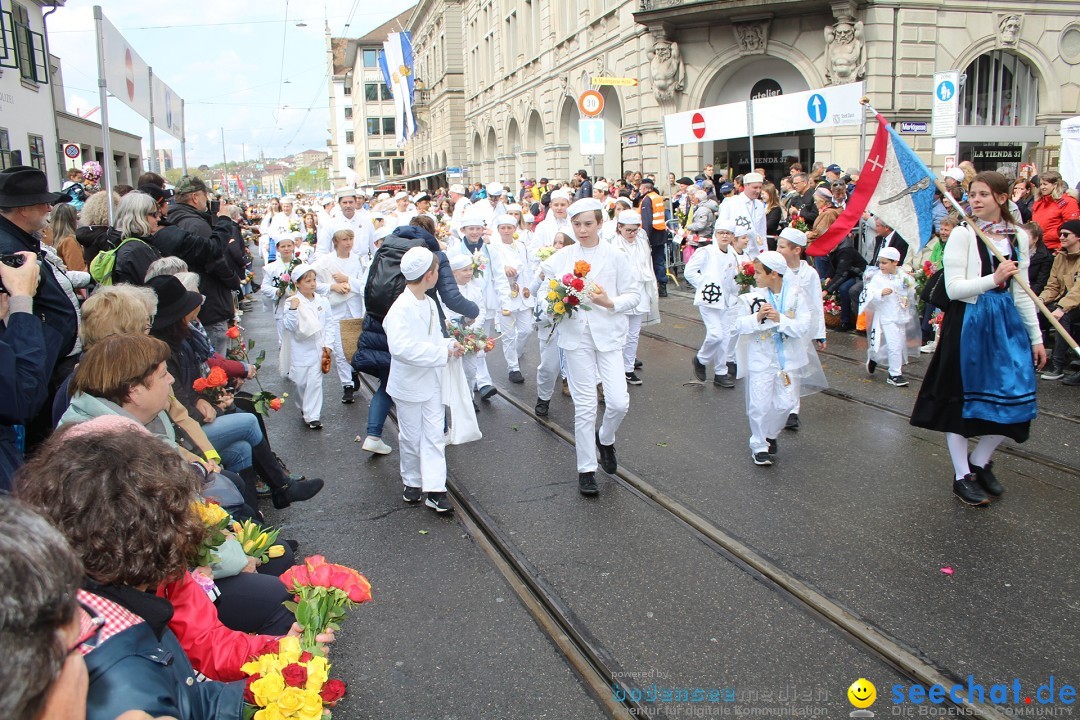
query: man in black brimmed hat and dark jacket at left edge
[{"left": 0, "top": 165, "right": 79, "bottom": 377}]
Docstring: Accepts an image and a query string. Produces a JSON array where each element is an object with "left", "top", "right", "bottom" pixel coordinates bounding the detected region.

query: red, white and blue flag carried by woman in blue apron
[{"left": 807, "top": 113, "right": 934, "bottom": 255}]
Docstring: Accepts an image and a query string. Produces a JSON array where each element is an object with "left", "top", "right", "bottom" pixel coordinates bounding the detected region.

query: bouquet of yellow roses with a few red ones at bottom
[{"left": 240, "top": 636, "right": 345, "bottom": 720}]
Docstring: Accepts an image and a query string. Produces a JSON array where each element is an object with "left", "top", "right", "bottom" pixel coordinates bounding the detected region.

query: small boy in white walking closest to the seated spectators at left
[{"left": 282, "top": 264, "right": 333, "bottom": 430}]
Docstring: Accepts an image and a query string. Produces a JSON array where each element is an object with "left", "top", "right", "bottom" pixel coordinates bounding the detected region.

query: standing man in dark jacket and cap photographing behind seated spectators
[{"left": 168, "top": 175, "right": 242, "bottom": 355}]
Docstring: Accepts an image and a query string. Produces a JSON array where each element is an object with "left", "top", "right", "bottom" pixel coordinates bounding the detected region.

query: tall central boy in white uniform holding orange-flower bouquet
[{"left": 540, "top": 198, "right": 642, "bottom": 495}]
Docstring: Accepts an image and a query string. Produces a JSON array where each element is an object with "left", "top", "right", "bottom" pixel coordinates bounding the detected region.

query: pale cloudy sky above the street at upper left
[{"left": 48, "top": 0, "right": 405, "bottom": 167}]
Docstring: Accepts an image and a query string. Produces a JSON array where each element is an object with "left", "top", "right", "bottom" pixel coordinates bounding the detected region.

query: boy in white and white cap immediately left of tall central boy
[{"left": 488, "top": 214, "right": 535, "bottom": 384}]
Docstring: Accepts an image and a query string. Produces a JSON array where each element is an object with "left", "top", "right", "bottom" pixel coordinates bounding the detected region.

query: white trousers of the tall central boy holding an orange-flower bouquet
[{"left": 564, "top": 348, "right": 630, "bottom": 473}]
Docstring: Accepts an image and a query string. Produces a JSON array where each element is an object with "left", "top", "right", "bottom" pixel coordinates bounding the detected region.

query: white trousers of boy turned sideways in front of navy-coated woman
[{"left": 394, "top": 392, "right": 446, "bottom": 492}]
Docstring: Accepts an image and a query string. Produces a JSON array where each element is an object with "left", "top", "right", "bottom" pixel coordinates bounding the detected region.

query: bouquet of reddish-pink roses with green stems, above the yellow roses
[{"left": 281, "top": 555, "right": 372, "bottom": 655}]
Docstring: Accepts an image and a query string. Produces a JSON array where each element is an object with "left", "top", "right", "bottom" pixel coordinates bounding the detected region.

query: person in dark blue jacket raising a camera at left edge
[{"left": 0, "top": 253, "right": 51, "bottom": 492}]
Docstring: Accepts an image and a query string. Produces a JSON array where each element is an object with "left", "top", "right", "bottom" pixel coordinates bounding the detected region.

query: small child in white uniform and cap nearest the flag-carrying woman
[{"left": 864, "top": 247, "right": 916, "bottom": 388}]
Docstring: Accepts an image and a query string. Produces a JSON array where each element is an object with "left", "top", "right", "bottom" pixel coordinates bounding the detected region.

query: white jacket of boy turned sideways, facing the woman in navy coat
[{"left": 382, "top": 287, "right": 454, "bottom": 403}]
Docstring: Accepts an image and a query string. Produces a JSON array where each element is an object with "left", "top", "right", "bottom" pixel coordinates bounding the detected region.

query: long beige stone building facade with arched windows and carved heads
[{"left": 405, "top": 0, "right": 1080, "bottom": 187}]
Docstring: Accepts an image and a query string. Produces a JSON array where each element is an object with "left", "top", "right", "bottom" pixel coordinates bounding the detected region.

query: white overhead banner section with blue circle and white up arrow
[{"left": 752, "top": 82, "right": 865, "bottom": 135}]
